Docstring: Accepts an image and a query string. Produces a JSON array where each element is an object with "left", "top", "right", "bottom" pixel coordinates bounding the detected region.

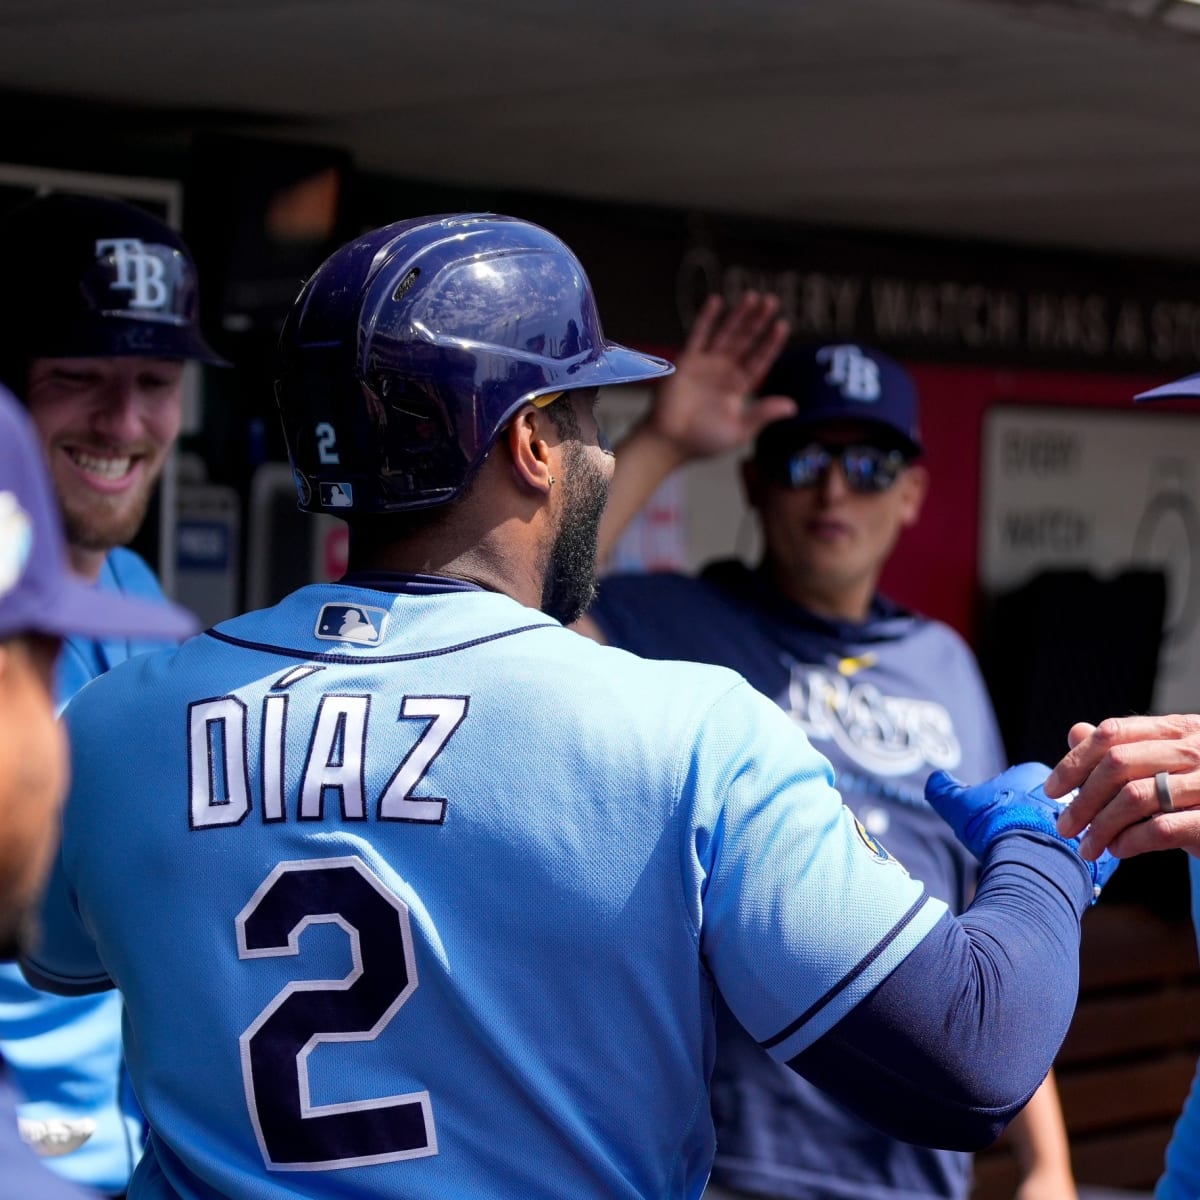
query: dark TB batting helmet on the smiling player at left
[{"left": 0, "top": 192, "right": 222, "bottom": 395}]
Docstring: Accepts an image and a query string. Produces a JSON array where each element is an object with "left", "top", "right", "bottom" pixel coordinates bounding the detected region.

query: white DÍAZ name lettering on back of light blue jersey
[{"left": 186, "top": 666, "right": 469, "bottom": 829}]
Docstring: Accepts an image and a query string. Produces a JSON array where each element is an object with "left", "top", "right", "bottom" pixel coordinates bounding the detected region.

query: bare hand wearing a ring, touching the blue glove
[{"left": 1045, "top": 715, "right": 1200, "bottom": 859}]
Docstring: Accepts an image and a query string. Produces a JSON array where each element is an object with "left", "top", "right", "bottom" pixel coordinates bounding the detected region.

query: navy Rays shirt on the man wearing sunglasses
[{"left": 589, "top": 560, "right": 1004, "bottom": 1200}]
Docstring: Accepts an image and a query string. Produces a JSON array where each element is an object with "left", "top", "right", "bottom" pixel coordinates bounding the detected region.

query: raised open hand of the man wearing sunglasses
[{"left": 649, "top": 292, "right": 796, "bottom": 462}]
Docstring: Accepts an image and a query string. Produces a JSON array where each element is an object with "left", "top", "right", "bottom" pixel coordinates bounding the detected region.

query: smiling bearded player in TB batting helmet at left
[{"left": 0, "top": 193, "right": 220, "bottom": 1195}]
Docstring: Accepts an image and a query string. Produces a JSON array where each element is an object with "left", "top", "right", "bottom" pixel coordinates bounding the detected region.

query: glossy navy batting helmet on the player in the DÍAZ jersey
[{"left": 276, "top": 214, "right": 674, "bottom": 517}]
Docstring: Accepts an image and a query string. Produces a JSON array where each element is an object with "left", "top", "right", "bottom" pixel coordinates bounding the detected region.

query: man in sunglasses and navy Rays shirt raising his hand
[{"left": 576, "top": 343, "right": 1075, "bottom": 1200}]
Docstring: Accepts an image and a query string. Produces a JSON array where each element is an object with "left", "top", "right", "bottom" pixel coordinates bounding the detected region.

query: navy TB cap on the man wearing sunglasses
[{"left": 755, "top": 343, "right": 923, "bottom": 457}]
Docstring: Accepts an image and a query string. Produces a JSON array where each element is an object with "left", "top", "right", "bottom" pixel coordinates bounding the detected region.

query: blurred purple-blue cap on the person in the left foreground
[{"left": 0, "top": 388, "right": 197, "bottom": 641}]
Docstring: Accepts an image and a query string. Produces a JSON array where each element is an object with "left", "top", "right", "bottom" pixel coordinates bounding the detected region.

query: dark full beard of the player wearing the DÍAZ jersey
[{"left": 541, "top": 444, "right": 608, "bottom": 625}]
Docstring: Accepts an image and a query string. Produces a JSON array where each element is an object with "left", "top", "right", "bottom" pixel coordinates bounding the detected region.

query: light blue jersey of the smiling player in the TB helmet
[{"left": 0, "top": 547, "right": 171, "bottom": 1195}]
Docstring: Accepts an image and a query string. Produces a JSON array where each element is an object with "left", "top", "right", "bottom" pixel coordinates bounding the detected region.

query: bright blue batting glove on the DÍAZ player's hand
[{"left": 925, "top": 762, "right": 1120, "bottom": 901}]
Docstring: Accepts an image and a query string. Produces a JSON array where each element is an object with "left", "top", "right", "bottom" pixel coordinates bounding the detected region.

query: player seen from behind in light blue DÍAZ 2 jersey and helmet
[{"left": 26, "top": 214, "right": 1111, "bottom": 1200}]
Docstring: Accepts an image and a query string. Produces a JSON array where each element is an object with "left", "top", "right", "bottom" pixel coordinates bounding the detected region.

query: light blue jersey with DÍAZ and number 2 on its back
[{"left": 32, "top": 577, "right": 946, "bottom": 1200}]
